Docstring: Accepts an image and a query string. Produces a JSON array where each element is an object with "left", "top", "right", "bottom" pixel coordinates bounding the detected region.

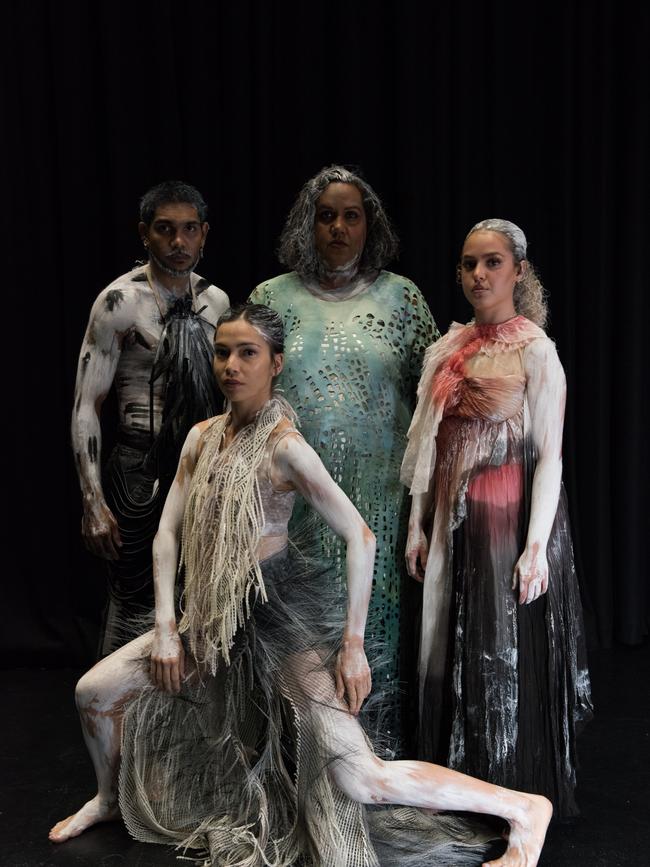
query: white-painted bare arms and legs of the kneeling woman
[{"left": 50, "top": 410, "right": 551, "bottom": 867}]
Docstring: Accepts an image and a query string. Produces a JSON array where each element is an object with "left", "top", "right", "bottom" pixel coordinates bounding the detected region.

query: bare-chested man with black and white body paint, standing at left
[{"left": 72, "top": 181, "right": 229, "bottom": 653}]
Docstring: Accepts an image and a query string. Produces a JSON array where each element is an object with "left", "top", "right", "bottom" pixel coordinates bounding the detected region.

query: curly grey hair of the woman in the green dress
[{"left": 278, "top": 165, "right": 399, "bottom": 277}]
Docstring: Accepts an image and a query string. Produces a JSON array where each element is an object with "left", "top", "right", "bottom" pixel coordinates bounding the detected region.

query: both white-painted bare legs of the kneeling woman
[{"left": 50, "top": 634, "right": 552, "bottom": 867}]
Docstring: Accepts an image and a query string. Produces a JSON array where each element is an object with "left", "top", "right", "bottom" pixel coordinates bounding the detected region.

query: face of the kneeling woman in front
[{"left": 213, "top": 319, "right": 283, "bottom": 406}]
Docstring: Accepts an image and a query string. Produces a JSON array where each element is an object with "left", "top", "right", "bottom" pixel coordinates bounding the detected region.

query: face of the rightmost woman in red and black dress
[{"left": 459, "top": 231, "right": 525, "bottom": 322}]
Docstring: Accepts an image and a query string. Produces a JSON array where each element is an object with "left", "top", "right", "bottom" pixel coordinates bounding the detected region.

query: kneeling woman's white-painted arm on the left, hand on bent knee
[{"left": 151, "top": 422, "right": 206, "bottom": 692}]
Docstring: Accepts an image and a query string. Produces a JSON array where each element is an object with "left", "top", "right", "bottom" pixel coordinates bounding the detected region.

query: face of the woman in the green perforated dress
[{"left": 314, "top": 183, "right": 366, "bottom": 271}]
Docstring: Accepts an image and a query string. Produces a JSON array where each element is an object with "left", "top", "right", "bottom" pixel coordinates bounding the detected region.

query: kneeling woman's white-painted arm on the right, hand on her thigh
[{"left": 272, "top": 434, "right": 375, "bottom": 715}]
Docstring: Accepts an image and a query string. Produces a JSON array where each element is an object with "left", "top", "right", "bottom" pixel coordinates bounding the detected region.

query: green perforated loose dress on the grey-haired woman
[{"left": 250, "top": 271, "right": 438, "bottom": 755}]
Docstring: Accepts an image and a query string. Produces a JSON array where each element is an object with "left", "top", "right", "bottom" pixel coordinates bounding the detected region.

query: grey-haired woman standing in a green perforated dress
[{"left": 250, "top": 166, "right": 438, "bottom": 755}]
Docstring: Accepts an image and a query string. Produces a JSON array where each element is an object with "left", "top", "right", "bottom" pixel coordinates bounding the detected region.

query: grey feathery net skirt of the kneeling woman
[{"left": 120, "top": 552, "right": 493, "bottom": 867}]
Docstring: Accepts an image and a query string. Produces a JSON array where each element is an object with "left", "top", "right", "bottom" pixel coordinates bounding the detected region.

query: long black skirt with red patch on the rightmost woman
[{"left": 420, "top": 423, "right": 592, "bottom": 819}]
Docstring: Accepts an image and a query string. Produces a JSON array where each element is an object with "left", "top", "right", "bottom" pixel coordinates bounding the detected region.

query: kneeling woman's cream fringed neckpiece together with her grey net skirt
[{"left": 120, "top": 399, "right": 494, "bottom": 867}]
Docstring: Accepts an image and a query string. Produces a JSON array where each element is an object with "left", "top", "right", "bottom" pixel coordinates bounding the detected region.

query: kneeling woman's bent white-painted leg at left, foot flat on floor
[{"left": 49, "top": 633, "right": 151, "bottom": 843}]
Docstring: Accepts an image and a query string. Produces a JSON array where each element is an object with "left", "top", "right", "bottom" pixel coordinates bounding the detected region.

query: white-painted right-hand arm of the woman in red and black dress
[{"left": 513, "top": 339, "right": 566, "bottom": 604}]
